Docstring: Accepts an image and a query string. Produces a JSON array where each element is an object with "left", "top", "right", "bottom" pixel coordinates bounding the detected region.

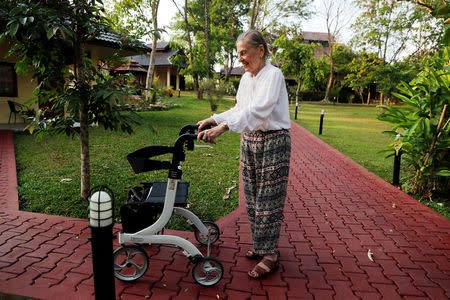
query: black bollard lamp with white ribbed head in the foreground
[{"left": 89, "top": 186, "right": 116, "bottom": 300}]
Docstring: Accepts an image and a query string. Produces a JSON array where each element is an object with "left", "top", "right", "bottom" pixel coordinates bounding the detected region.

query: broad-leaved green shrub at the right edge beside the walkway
[{"left": 380, "top": 47, "right": 450, "bottom": 198}]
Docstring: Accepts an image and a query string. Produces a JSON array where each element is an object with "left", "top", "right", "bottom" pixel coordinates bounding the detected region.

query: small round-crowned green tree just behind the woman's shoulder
[{"left": 274, "top": 35, "right": 316, "bottom": 119}]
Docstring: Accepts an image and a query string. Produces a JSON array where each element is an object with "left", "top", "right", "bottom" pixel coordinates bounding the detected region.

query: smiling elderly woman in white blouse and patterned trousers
[{"left": 198, "top": 30, "right": 291, "bottom": 279}]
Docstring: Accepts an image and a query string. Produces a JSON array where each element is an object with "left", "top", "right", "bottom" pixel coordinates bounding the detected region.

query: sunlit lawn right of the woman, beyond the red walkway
[{"left": 290, "top": 102, "right": 450, "bottom": 218}]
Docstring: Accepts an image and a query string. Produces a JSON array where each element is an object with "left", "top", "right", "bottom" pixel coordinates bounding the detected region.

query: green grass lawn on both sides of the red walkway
[{"left": 14, "top": 97, "right": 450, "bottom": 229}]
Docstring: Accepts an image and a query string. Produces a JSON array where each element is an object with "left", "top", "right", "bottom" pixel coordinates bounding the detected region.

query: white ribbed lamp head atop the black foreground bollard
[{"left": 89, "top": 191, "right": 114, "bottom": 227}]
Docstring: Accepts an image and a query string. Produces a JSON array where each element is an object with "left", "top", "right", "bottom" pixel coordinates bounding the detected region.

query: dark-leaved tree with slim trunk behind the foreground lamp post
[{"left": 0, "top": 0, "right": 151, "bottom": 199}]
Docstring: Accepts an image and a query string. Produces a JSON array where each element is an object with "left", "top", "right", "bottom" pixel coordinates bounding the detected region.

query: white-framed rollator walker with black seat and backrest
[{"left": 114, "top": 125, "right": 223, "bottom": 286}]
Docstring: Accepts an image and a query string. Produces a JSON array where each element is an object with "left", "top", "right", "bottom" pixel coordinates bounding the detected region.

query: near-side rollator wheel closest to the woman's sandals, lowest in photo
[{"left": 192, "top": 256, "right": 223, "bottom": 286}]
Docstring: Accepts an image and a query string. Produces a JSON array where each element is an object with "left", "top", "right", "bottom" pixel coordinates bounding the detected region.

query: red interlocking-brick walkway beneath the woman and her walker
[{"left": 0, "top": 124, "right": 450, "bottom": 300}]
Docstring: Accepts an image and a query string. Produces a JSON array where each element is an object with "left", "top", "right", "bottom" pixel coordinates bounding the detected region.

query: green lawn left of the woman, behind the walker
[{"left": 14, "top": 98, "right": 243, "bottom": 229}]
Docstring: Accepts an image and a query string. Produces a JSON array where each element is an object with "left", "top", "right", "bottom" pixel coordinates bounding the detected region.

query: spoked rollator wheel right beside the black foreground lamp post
[{"left": 114, "top": 245, "right": 148, "bottom": 281}]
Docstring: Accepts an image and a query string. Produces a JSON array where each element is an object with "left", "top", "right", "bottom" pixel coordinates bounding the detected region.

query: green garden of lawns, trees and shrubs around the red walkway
[{"left": 0, "top": 0, "right": 450, "bottom": 228}]
